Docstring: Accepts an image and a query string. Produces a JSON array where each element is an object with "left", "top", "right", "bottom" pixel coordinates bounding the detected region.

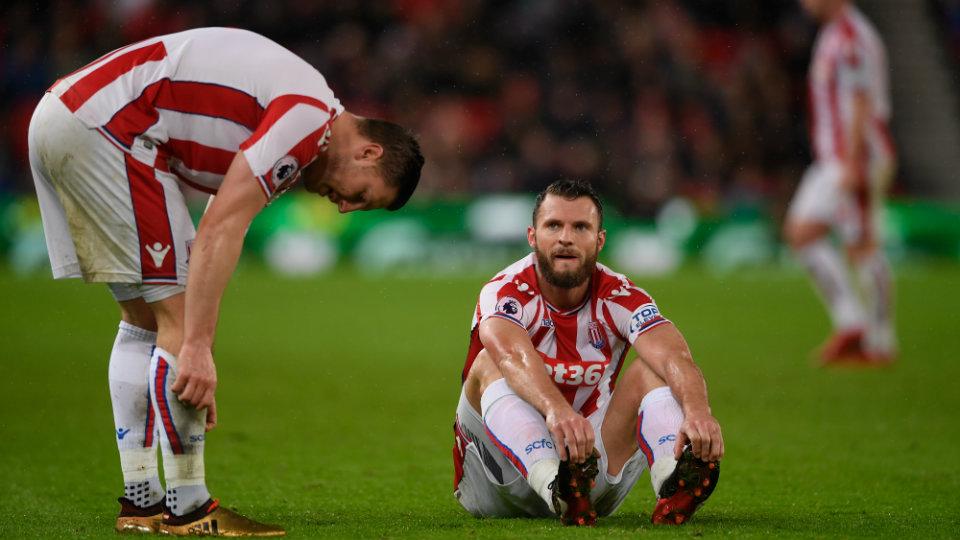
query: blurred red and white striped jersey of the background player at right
[{"left": 809, "top": 5, "right": 895, "bottom": 167}]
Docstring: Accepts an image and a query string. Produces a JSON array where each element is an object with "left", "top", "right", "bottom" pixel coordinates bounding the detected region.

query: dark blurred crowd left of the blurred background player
[{"left": 0, "top": 0, "right": 815, "bottom": 217}]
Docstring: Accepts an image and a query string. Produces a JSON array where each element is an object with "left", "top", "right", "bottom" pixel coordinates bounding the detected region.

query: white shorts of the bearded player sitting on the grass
[{"left": 453, "top": 390, "right": 647, "bottom": 517}]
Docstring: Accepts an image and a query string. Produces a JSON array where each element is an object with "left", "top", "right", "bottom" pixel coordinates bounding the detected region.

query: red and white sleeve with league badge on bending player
[{"left": 240, "top": 95, "right": 342, "bottom": 201}]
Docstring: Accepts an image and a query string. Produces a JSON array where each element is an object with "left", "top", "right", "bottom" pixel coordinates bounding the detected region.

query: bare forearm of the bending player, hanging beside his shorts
[{"left": 184, "top": 221, "right": 245, "bottom": 348}]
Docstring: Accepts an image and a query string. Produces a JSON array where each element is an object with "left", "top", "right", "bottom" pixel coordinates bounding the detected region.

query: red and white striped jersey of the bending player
[{"left": 50, "top": 28, "right": 343, "bottom": 199}]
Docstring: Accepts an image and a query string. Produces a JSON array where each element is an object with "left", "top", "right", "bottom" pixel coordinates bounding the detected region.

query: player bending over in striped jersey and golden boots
[{"left": 29, "top": 28, "right": 423, "bottom": 536}]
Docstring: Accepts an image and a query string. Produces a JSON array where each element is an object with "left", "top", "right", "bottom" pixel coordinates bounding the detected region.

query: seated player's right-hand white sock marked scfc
[{"left": 637, "top": 386, "right": 683, "bottom": 494}]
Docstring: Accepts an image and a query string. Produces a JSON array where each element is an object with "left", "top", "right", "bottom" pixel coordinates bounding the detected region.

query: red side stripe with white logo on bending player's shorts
[{"left": 124, "top": 154, "right": 177, "bottom": 283}]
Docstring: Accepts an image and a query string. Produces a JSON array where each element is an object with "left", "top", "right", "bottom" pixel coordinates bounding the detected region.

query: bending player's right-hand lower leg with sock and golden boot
[{"left": 144, "top": 293, "right": 286, "bottom": 536}]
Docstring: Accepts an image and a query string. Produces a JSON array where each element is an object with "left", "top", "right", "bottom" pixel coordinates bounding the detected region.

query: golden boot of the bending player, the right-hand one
[{"left": 159, "top": 499, "right": 287, "bottom": 536}]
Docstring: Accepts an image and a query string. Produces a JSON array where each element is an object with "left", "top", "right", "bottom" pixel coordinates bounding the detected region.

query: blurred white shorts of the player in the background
[{"left": 788, "top": 162, "right": 893, "bottom": 244}]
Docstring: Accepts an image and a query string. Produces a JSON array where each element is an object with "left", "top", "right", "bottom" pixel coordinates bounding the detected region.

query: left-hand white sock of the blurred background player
[{"left": 798, "top": 239, "right": 863, "bottom": 330}]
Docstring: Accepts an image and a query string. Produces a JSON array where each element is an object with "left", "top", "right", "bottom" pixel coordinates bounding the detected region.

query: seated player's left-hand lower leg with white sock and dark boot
[{"left": 464, "top": 351, "right": 599, "bottom": 525}]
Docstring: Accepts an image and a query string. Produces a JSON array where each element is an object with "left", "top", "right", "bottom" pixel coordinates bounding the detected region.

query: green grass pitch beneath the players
[{"left": 0, "top": 267, "right": 960, "bottom": 538}]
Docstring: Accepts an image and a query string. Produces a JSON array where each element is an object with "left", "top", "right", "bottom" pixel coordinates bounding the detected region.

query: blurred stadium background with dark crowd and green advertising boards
[{"left": 0, "top": 0, "right": 960, "bottom": 275}]
